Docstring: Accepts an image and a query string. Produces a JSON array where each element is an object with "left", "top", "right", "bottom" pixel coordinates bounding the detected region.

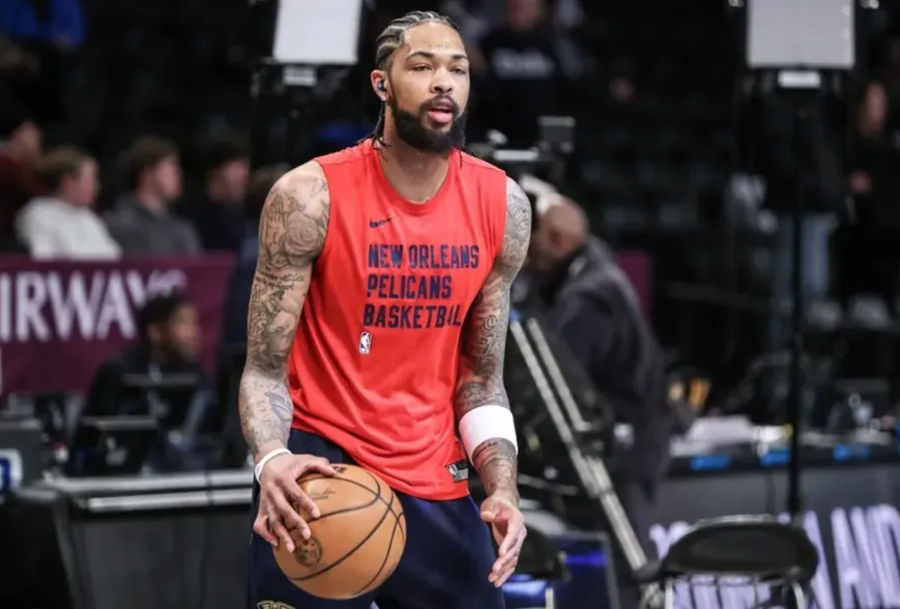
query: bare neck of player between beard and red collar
[{"left": 379, "top": 129, "right": 450, "bottom": 203}]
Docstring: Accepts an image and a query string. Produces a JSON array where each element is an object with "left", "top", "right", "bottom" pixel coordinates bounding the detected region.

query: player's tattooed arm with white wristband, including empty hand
[{"left": 454, "top": 179, "right": 531, "bottom": 586}]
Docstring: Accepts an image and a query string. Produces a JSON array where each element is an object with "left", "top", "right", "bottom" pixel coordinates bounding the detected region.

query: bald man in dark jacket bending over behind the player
[{"left": 517, "top": 195, "right": 671, "bottom": 606}]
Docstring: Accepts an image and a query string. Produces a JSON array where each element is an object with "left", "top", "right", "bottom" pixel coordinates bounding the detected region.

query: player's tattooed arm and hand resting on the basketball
[{"left": 239, "top": 163, "right": 334, "bottom": 552}]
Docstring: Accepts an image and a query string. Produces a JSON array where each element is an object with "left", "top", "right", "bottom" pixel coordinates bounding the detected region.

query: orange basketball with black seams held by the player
[{"left": 274, "top": 464, "right": 406, "bottom": 599}]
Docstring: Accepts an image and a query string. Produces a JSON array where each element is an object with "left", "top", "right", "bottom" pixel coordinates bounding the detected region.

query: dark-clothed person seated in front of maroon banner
[{"left": 81, "top": 294, "right": 212, "bottom": 470}]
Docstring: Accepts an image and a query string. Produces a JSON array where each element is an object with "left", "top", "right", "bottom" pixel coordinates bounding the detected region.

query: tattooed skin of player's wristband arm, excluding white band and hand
[{"left": 454, "top": 180, "right": 531, "bottom": 493}]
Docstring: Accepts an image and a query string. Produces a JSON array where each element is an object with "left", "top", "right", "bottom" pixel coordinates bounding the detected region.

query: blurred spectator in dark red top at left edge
[{"left": 0, "top": 102, "right": 43, "bottom": 251}]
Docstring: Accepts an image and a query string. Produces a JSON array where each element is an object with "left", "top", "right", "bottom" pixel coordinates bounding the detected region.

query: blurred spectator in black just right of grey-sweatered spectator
[{"left": 184, "top": 136, "right": 250, "bottom": 252}]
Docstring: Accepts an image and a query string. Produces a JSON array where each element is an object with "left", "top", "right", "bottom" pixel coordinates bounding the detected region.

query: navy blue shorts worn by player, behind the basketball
[{"left": 249, "top": 430, "right": 505, "bottom": 609}]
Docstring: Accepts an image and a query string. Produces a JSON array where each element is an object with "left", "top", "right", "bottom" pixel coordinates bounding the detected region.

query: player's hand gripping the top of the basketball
[{"left": 253, "top": 455, "right": 335, "bottom": 552}]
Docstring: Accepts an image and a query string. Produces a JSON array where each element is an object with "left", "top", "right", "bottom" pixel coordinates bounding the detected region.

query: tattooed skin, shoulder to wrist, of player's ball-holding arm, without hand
[{"left": 239, "top": 170, "right": 329, "bottom": 458}]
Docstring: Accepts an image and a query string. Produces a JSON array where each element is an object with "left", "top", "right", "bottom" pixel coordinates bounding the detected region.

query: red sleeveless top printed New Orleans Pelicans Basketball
[{"left": 288, "top": 142, "right": 506, "bottom": 500}]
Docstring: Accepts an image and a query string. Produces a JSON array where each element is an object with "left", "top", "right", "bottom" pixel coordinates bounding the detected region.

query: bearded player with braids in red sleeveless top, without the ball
[{"left": 240, "top": 11, "right": 531, "bottom": 609}]
